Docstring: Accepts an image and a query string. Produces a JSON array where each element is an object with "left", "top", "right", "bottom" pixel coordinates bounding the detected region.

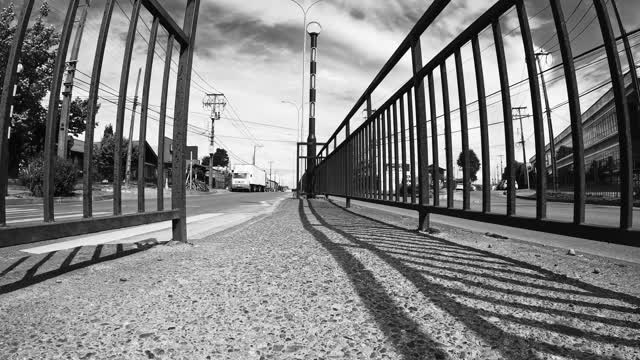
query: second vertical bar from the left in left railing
[{"left": 42, "top": 0, "right": 79, "bottom": 222}]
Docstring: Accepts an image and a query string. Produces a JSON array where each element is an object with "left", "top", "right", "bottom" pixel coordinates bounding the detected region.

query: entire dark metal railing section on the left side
[{"left": 0, "top": 0, "right": 200, "bottom": 247}]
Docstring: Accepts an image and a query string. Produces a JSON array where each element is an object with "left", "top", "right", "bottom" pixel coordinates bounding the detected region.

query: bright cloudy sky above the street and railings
[{"left": 0, "top": 0, "right": 640, "bottom": 185}]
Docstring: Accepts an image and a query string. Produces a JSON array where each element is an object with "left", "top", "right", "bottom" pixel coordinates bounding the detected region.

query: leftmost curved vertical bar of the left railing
[{"left": 0, "top": 0, "right": 34, "bottom": 226}]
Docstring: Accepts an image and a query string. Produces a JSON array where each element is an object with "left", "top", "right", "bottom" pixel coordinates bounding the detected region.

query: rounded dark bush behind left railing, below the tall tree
[{"left": 19, "top": 156, "right": 78, "bottom": 197}]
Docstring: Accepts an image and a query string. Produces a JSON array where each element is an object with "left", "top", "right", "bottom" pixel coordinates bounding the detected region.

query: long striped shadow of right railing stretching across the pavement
[{"left": 300, "top": 201, "right": 640, "bottom": 359}]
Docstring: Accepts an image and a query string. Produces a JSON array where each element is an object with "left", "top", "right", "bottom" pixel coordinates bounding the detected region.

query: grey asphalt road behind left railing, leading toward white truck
[{"left": 7, "top": 192, "right": 284, "bottom": 225}]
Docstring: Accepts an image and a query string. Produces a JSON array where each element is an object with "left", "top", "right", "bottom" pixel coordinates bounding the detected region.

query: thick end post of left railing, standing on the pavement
[{"left": 171, "top": 0, "right": 200, "bottom": 242}]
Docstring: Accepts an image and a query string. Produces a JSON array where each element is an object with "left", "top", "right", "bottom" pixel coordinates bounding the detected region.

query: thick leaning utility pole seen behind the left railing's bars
[{"left": 58, "top": 0, "right": 89, "bottom": 159}]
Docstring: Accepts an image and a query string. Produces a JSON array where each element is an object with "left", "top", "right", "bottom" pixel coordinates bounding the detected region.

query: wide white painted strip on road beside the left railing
[{"left": 21, "top": 213, "right": 222, "bottom": 254}]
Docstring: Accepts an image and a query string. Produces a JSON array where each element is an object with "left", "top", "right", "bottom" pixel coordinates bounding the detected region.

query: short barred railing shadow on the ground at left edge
[{"left": 0, "top": 244, "right": 149, "bottom": 295}]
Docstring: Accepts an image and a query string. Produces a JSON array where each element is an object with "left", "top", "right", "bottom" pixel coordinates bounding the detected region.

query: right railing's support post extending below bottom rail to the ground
[{"left": 411, "top": 37, "right": 435, "bottom": 231}]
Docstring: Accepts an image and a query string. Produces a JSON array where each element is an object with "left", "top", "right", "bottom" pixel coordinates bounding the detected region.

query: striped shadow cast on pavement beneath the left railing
[{"left": 0, "top": 244, "right": 151, "bottom": 295}]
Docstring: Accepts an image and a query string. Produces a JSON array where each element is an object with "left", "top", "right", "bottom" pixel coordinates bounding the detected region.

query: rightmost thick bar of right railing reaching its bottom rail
[{"left": 593, "top": 0, "right": 634, "bottom": 229}]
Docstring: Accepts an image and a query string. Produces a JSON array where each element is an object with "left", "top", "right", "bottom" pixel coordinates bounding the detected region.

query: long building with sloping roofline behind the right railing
[{"left": 530, "top": 74, "right": 640, "bottom": 196}]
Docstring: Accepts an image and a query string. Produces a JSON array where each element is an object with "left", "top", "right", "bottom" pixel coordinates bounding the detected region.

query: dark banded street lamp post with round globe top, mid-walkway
[{"left": 307, "top": 21, "right": 322, "bottom": 199}]
